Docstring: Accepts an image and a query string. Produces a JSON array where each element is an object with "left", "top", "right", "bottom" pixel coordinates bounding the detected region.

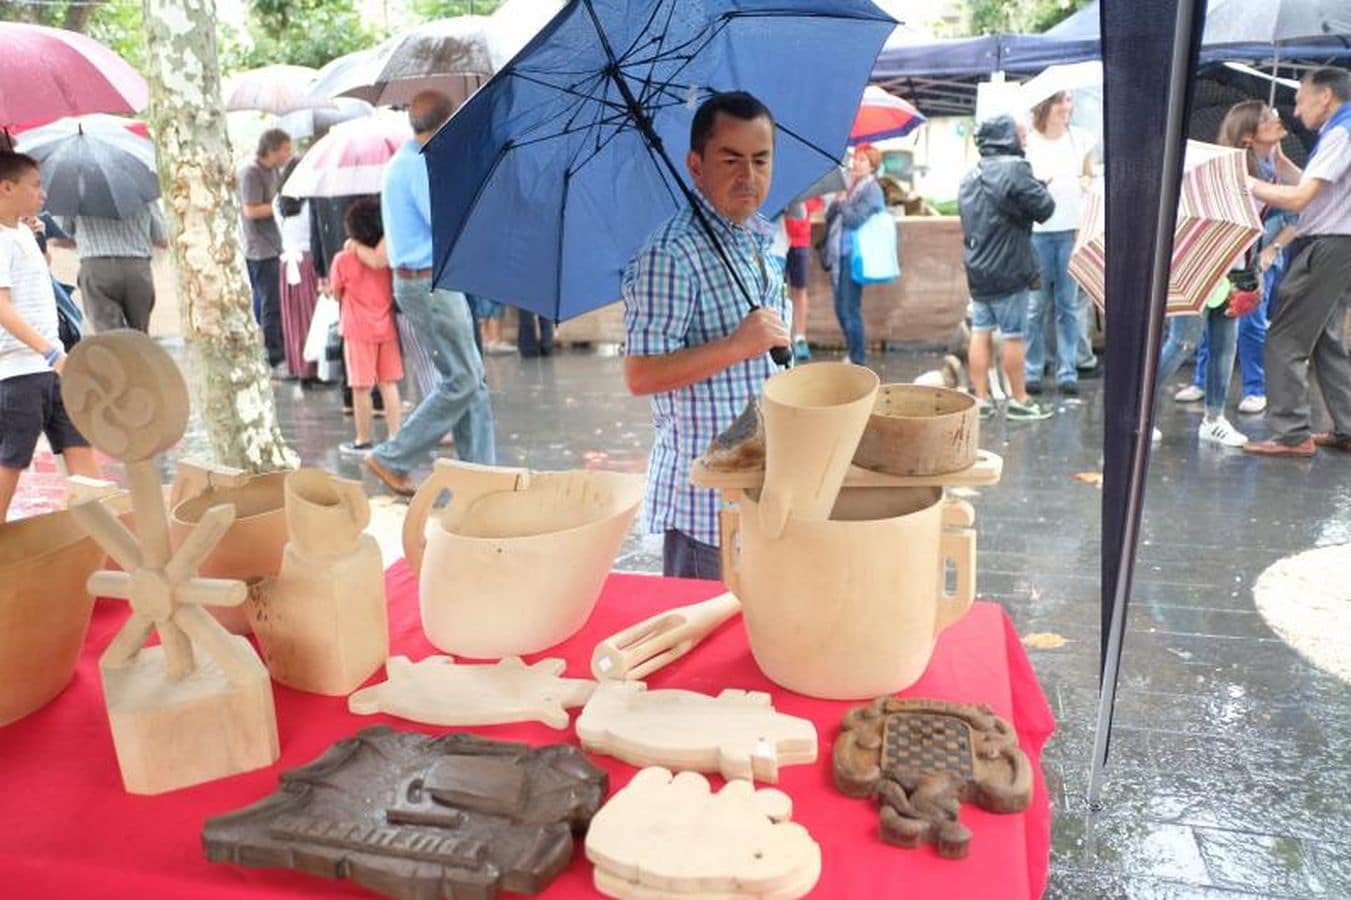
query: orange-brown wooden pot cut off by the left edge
[{"left": 0, "top": 511, "right": 117, "bottom": 726}]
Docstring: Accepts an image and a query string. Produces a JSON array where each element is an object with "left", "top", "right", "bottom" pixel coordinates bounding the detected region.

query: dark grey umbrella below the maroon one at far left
[{"left": 19, "top": 119, "right": 159, "bottom": 219}]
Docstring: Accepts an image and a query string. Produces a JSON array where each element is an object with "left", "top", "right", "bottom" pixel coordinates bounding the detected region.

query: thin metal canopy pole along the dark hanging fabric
[{"left": 1088, "top": 0, "right": 1196, "bottom": 809}]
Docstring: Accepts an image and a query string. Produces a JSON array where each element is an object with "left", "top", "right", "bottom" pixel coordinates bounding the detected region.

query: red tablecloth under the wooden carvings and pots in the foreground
[{"left": 0, "top": 562, "right": 1054, "bottom": 900}]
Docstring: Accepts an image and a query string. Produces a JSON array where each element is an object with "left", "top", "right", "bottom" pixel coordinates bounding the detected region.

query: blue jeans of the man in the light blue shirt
[{"left": 373, "top": 278, "right": 497, "bottom": 474}]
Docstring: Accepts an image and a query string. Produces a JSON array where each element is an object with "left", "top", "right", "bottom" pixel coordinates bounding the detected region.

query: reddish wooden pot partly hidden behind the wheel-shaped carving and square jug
[{"left": 169, "top": 472, "right": 289, "bottom": 634}]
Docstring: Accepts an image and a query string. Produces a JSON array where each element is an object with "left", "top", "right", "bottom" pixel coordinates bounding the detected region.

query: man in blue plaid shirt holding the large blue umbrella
[{"left": 623, "top": 92, "right": 790, "bottom": 580}]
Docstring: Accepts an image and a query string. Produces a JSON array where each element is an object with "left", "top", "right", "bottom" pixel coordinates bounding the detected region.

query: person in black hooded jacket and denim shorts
[{"left": 958, "top": 115, "right": 1055, "bottom": 419}]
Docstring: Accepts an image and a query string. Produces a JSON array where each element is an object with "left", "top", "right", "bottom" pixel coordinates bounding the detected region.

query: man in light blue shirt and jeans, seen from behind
[{"left": 365, "top": 91, "right": 497, "bottom": 496}]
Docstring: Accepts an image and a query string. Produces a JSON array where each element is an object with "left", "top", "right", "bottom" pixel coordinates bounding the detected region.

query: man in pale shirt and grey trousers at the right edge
[{"left": 1243, "top": 69, "right": 1351, "bottom": 457}]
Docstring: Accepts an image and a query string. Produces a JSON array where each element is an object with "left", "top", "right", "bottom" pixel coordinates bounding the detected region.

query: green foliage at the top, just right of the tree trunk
[{"left": 218, "top": 0, "right": 384, "bottom": 72}]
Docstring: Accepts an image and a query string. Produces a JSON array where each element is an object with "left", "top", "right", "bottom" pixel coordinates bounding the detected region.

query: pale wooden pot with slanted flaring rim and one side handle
[{"left": 404, "top": 459, "right": 644, "bottom": 659}]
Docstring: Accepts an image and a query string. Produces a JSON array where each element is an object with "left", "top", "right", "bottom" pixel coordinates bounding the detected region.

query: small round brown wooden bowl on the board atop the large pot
[{"left": 854, "top": 384, "right": 981, "bottom": 476}]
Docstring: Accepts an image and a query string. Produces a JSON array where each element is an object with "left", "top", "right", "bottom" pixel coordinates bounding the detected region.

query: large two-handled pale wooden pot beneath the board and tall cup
[{"left": 723, "top": 488, "right": 975, "bottom": 700}]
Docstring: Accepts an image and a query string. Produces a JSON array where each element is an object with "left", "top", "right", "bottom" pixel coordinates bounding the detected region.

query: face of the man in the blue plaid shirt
[{"left": 685, "top": 112, "right": 774, "bottom": 224}]
